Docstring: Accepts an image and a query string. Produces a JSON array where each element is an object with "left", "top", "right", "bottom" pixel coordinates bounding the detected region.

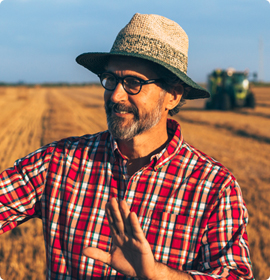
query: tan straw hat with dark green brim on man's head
[{"left": 76, "top": 13, "right": 210, "bottom": 99}]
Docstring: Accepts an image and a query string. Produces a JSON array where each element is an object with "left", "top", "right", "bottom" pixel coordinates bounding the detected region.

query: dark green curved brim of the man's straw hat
[{"left": 76, "top": 51, "right": 210, "bottom": 99}]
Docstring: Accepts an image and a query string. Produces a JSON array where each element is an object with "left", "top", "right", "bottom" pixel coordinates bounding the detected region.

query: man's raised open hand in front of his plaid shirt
[{"left": 83, "top": 198, "right": 157, "bottom": 279}]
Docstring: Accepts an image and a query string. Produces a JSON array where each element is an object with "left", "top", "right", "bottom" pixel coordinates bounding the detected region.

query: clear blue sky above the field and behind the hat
[{"left": 0, "top": 0, "right": 270, "bottom": 83}]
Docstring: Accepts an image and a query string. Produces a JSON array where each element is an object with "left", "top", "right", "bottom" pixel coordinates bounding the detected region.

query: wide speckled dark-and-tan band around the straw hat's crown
[{"left": 110, "top": 34, "right": 188, "bottom": 74}]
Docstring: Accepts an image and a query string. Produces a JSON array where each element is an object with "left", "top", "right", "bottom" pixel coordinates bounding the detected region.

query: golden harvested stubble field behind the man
[{"left": 0, "top": 87, "right": 270, "bottom": 280}]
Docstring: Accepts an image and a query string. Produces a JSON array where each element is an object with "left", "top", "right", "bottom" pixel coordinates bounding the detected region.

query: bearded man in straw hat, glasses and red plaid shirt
[{"left": 0, "top": 14, "right": 253, "bottom": 279}]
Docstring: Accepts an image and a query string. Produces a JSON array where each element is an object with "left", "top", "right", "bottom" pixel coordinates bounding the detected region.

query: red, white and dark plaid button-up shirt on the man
[{"left": 0, "top": 120, "right": 253, "bottom": 279}]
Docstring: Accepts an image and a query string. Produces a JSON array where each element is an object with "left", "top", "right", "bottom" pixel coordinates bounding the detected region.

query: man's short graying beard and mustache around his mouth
[{"left": 105, "top": 97, "right": 164, "bottom": 140}]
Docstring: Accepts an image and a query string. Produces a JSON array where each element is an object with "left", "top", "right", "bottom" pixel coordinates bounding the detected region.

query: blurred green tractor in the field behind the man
[{"left": 205, "top": 69, "right": 255, "bottom": 111}]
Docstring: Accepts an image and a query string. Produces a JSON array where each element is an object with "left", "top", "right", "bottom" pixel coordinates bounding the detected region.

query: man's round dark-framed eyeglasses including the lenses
[{"left": 98, "top": 72, "right": 162, "bottom": 95}]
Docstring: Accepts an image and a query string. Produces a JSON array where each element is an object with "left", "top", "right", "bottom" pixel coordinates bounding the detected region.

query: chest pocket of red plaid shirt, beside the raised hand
[{"left": 143, "top": 210, "right": 198, "bottom": 269}]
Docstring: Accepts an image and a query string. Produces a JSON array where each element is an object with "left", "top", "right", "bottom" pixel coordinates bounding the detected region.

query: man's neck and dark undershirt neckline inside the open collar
[{"left": 117, "top": 126, "right": 169, "bottom": 176}]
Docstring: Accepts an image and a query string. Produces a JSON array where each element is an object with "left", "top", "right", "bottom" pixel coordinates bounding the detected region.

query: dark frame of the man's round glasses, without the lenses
[{"left": 98, "top": 72, "right": 163, "bottom": 95}]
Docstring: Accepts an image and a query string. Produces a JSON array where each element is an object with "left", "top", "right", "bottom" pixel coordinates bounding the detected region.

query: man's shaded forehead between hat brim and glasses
[{"left": 106, "top": 56, "right": 160, "bottom": 78}]
